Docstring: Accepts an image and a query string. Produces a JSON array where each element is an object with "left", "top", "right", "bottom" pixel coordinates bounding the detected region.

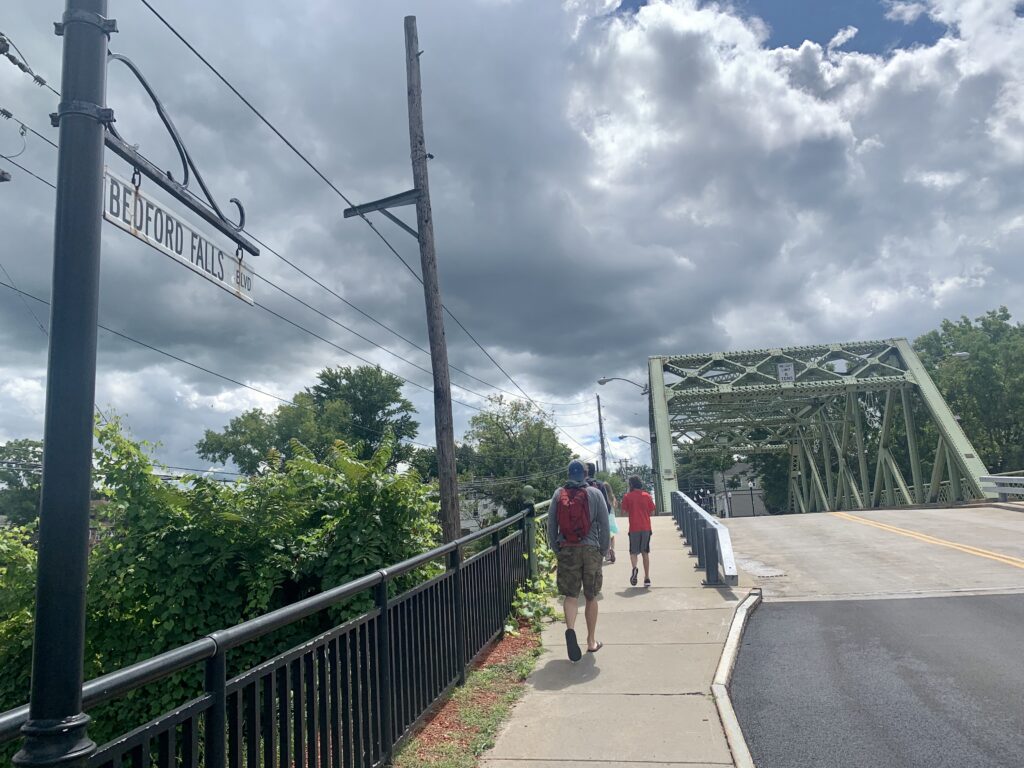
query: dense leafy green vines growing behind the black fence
[{"left": 0, "top": 421, "right": 439, "bottom": 759}]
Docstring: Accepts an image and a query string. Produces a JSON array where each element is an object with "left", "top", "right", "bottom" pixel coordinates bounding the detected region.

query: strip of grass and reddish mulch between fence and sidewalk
[{"left": 394, "top": 629, "right": 541, "bottom": 768}]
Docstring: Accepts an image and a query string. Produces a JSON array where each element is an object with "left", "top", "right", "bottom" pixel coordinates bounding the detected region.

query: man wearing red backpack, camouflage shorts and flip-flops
[{"left": 548, "top": 460, "right": 608, "bottom": 662}]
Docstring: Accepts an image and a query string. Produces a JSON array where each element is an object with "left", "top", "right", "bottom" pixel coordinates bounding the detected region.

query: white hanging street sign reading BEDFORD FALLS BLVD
[{"left": 103, "top": 168, "right": 254, "bottom": 304}]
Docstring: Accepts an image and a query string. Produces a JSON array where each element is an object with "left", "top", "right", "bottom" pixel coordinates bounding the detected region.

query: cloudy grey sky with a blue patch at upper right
[{"left": 0, "top": 0, "right": 1024, "bottom": 475}]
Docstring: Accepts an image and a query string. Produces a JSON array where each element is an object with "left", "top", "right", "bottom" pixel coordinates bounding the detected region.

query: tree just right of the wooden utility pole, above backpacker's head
[{"left": 465, "top": 397, "right": 572, "bottom": 512}]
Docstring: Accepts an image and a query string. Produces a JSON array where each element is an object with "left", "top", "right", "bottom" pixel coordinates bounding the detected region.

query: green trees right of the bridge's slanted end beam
[{"left": 913, "top": 306, "right": 1024, "bottom": 472}]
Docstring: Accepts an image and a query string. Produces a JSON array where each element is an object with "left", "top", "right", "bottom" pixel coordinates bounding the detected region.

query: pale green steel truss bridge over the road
[{"left": 648, "top": 339, "right": 987, "bottom": 512}]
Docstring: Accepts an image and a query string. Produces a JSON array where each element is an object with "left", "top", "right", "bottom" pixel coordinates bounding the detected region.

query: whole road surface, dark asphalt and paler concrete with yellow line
[{"left": 729, "top": 508, "right": 1024, "bottom": 768}]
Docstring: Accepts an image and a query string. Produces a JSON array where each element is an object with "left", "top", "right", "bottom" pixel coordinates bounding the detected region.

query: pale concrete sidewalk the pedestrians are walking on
[{"left": 482, "top": 517, "right": 746, "bottom": 768}]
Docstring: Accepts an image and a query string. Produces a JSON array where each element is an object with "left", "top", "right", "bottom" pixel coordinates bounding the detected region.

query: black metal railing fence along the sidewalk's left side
[{"left": 0, "top": 509, "right": 538, "bottom": 768}]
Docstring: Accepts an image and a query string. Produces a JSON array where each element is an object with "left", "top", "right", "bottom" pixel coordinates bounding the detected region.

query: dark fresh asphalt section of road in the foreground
[{"left": 731, "top": 594, "right": 1024, "bottom": 768}]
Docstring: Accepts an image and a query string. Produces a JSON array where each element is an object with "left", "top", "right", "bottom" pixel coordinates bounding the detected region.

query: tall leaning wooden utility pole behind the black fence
[{"left": 406, "top": 16, "right": 462, "bottom": 542}]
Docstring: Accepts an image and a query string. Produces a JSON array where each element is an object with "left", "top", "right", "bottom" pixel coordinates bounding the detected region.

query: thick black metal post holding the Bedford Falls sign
[{"left": 14, "top": 0, "right": 111, "bottom": 767}]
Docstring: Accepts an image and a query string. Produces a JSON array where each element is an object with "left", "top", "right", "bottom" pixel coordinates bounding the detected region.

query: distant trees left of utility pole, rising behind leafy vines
[{"left": 196, "top": 366, "right": 420, "bottom": 475}]
